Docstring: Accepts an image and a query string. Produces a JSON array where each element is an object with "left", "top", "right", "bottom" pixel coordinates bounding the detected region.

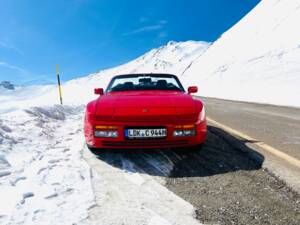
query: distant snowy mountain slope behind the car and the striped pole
[{"left": 0, "top": 41, "right": 210, "bottom": 112}]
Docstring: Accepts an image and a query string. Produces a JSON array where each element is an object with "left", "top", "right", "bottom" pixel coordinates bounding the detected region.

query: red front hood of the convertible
[{"left": 95, "top": 92, "right": 198, "bottom": 122}]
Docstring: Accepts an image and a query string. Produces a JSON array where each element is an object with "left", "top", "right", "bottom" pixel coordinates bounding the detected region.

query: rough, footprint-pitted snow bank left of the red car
[{"left": 0, "top": 106, "right": 94, "bottom": 224}]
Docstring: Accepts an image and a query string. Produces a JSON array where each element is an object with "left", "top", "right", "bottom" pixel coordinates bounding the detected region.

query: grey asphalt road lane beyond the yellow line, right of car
[{"left": 201, "top": 98, "right": 300, "bottom": 159}]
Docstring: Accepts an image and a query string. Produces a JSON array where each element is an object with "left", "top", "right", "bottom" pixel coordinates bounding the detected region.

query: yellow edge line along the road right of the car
[{"left": 206, "top": 117, "right": 300, "bottom": 168}]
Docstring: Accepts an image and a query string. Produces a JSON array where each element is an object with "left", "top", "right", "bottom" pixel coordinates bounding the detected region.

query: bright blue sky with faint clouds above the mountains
[{"left": 0, "top": 0, "right": 259, "bottom": 85}]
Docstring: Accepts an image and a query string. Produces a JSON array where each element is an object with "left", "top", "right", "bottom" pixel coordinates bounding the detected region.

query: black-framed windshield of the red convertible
[{"left": 106, "top": 74, "right": 184, "bottom": 92}]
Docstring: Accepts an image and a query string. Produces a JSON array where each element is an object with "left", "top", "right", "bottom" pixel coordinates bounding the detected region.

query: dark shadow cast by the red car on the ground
[{"left": 93, "top": 126, "right": 264, "bottom": 177}]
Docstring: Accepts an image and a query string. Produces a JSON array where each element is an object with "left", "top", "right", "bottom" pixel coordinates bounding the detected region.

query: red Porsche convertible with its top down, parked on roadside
[{"left": 84, "top": 73, "right": 207, "bottom": 149}]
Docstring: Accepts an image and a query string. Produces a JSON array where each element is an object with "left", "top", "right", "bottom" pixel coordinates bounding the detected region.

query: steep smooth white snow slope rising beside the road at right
[{"left": 185, "top": 0, "right": 300, "bottom": 107}]
